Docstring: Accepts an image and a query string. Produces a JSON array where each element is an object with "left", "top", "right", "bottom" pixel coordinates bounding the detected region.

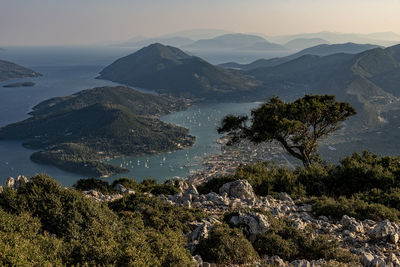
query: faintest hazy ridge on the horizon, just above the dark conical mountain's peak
[{"left": 117, "top": 36, "right": 194, "bottom": 48}]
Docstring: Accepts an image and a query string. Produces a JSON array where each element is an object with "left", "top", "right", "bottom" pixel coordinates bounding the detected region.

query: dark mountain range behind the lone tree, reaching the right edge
[{"left": 248, "top": 45, "right": 400, "bottom": 129}]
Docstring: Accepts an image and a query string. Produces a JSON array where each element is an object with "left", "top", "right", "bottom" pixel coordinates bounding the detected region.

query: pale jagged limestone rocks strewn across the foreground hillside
[{"left": 0, "top": 176, "right": 400, "bottom": 266}]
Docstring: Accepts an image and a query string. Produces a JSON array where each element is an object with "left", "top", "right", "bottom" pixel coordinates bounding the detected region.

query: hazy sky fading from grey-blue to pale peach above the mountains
[{"left": 0, "top": 0, "right": 400, "bottom": 46}]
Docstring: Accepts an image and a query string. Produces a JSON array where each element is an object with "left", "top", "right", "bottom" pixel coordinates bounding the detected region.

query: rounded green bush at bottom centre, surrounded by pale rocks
[{"left": 195, "top": 224, "right": 258, "bottom": 265}]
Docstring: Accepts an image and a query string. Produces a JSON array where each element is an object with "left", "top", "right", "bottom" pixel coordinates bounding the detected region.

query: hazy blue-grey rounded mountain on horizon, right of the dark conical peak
[{"left": 183, "top": 33, "right": 287, "bottom": 51}]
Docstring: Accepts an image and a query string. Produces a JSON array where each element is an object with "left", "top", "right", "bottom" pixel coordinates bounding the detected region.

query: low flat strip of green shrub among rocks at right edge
[{"left": 313, "top": 196, "right": 400, "bottom": 221}]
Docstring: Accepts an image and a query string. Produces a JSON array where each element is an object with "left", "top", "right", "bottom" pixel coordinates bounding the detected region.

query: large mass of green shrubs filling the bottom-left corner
[{"left": 0, "top": 175, "right": 198, "bottom": 266}]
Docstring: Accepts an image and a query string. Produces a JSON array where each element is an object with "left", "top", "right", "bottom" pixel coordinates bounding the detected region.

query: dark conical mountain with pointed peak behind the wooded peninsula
[{"left": 99, "top": 44, "right": 259, "bottom": 100}]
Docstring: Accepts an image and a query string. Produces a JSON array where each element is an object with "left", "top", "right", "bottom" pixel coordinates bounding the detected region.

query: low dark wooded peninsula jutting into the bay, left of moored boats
[{"left": 0, "top": 86, "right": 195, "bottom": 177}]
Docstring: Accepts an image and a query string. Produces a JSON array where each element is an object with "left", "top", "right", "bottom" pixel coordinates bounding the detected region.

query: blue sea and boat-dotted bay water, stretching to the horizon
[{"left": 0, "top": 47, "right": 266, "bottom": 186}]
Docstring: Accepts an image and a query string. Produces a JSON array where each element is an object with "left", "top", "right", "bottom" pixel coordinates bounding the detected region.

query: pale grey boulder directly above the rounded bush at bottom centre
[{"left": 230, "top": 212, "right": 270, "bottom": 235}]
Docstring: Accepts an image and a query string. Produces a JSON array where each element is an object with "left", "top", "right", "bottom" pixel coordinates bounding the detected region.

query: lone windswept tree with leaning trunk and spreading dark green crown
[{"left": 218, "top": 95, "right": 356, "bottom": 167}]
